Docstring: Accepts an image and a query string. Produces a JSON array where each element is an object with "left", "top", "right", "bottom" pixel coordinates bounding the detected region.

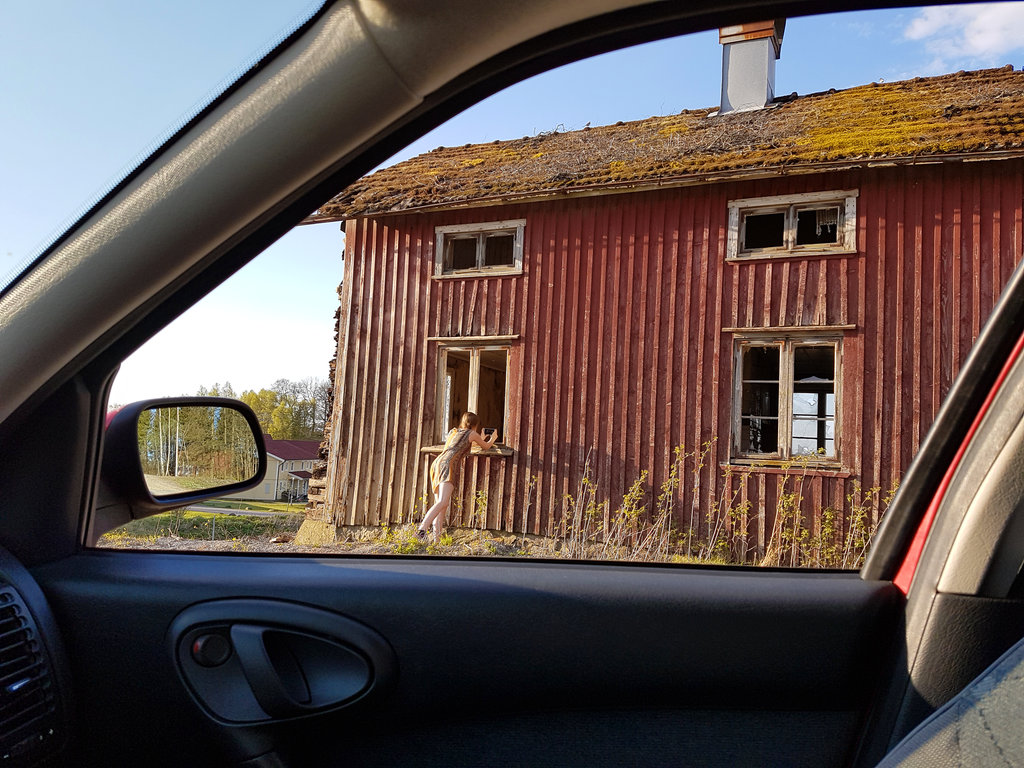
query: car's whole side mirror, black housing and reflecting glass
[{"left": 89, "top": 397, "right": 266, "bottom": 543}]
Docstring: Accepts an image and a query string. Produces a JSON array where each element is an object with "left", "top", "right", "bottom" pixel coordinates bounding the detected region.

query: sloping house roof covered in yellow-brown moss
[{"left": 309, "top": 67, "right": 1024, "bottom": 221}]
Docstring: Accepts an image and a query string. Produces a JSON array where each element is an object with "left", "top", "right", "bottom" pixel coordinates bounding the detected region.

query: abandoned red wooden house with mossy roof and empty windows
[{"left": 299, "top": 25, "right": 1024, "bottom": 561}]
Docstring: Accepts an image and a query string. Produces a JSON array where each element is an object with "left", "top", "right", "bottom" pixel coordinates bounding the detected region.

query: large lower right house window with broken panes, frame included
[{"left": 732, "top": 337, "right": 840, "bottom": 462}]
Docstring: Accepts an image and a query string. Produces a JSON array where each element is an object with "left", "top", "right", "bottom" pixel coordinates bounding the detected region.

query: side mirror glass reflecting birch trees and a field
[{"left": 138, "top": 406, "right": 259, "bottom": 498}]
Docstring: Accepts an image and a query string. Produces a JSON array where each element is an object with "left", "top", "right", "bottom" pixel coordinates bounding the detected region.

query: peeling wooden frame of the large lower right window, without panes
[{"left": 729, "top": 334, "right": 843, "bottom": 468}]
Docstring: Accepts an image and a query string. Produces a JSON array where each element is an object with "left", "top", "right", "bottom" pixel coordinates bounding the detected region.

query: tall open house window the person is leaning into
[{"left": 437, "top": 345, "right": 509, "bottom": 444}]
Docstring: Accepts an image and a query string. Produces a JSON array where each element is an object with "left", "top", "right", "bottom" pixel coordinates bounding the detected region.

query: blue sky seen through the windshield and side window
[{"left": 6, "top": 0, "right": 1024, "bottom": 403}]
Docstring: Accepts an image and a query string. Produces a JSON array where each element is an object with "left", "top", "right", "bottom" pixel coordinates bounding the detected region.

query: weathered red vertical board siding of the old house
[{"left": 327, "top": 161, "right": 1024, "bottom": 559}]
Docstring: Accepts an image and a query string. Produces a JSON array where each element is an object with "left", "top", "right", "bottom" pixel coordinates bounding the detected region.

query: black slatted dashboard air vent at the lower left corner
[{"left": 0, "top": 584, "right": 58, "bottom": 765}]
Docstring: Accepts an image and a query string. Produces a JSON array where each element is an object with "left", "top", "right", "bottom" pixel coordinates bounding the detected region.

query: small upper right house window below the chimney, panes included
[{"left": 727, "top": 189, "right": 857, "bottom": 258}]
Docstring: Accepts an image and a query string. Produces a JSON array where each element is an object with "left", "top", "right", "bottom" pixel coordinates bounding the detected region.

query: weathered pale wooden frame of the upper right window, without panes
[{"left": 726, "top": 189, "right": 859, "bottom": 261}]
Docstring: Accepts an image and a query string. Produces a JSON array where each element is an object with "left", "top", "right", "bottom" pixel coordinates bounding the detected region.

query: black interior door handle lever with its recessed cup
[{"left": 230, "top": 624, "right": 373, "bottom": 718}]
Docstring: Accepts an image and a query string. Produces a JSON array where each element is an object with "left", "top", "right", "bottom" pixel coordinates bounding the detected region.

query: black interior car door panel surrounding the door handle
[{"left": 34, "top": 551, "right": 901, "bottom": 765}]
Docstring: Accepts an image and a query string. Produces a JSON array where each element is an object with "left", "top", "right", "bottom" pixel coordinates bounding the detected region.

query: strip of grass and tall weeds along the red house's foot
[{"left": 99, "top": 460, "right": 896, "bottom": 568}]
